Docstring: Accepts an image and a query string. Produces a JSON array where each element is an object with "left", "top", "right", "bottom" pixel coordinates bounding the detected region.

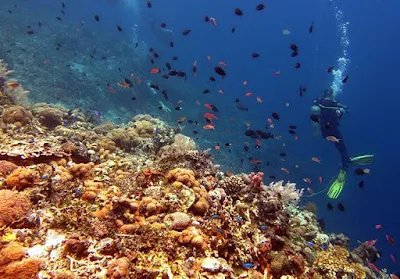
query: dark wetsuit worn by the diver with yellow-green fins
[{"left": 313, "top": 97, "right": 350, "bottom": 171}]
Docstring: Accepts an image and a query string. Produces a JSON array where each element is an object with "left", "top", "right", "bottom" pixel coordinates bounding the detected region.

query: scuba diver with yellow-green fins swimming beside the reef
[{"left": 311, "top": 88, "right": 374, "bottom": 199}]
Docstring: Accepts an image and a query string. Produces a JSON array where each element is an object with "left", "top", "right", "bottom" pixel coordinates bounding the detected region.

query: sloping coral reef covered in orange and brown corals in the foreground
[{"left": 0, "top": 58, "right": 378, "bottom": 279}]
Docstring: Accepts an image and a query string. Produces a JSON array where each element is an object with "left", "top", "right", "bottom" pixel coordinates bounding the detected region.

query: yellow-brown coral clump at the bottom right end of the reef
[{"left": 314, "top": 246, "right": 366, "bottom": 279}]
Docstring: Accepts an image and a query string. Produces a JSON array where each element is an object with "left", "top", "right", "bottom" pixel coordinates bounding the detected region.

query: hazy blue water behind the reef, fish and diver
[{"left": 0, "top": 0, "right": 400, "bottom": 272}]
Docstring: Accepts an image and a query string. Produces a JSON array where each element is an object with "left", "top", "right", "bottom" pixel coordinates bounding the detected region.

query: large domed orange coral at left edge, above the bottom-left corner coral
[{"left": 0, "top": 190, "right": 31, "bottom": 227}]
